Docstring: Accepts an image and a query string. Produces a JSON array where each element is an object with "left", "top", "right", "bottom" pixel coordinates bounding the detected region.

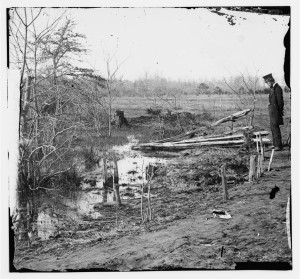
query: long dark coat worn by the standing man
[{"left": 269, "top": 83, "right": 283, "bottom": 126}]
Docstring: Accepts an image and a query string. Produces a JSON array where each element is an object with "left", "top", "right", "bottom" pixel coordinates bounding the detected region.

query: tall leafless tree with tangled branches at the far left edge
[{"left": 9, "top": 8, "right": 88, "bottom": 242}]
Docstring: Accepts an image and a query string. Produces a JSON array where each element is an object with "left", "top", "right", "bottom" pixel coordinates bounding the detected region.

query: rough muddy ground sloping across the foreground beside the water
[{"left": 14, "top": 144, "right": 292, "bottom": 271}]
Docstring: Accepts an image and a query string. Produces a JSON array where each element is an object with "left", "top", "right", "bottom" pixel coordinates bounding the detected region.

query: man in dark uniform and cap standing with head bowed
[{"left": 263, "top": 74, "right": 283, "bottom": 151}]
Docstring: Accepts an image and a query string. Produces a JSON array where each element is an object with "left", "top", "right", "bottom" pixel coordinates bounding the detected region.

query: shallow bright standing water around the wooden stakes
[{"left": 37, "top": 137, "right": 166, "bottom": 239}]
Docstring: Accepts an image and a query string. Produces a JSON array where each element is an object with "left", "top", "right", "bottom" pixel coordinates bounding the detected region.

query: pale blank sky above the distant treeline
[{"left": 61, "top": 8, "right": 289, "bottom": 83}]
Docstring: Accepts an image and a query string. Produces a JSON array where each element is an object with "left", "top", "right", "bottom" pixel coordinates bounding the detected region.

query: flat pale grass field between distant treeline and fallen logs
[{"left": 113, "top": 93, "right": 291, "bottom": 142}]
